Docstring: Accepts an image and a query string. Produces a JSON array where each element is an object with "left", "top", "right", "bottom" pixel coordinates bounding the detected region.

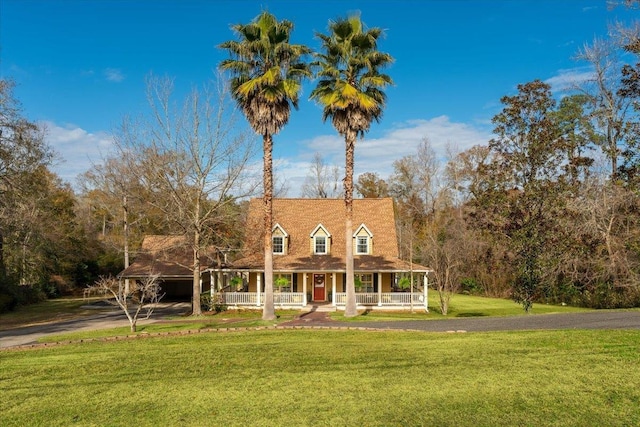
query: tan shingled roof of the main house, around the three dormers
[{"left": 233, "top": 198, "right": 429, "bottom": 271}]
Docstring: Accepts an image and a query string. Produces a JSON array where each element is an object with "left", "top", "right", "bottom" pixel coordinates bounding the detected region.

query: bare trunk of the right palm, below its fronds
[{"left": 344, "top": 132, "right": 358, "bottom": 317}]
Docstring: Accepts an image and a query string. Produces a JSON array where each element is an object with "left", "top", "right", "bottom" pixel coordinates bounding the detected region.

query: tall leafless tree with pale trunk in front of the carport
[{"left": 116, "top": 76, "right": 257, "bottom": 316}]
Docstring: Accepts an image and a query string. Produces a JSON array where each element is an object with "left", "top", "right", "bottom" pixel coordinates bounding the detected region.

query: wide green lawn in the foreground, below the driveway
[{"left": 0, "top": 330, "right": 640, "bottom": 426}]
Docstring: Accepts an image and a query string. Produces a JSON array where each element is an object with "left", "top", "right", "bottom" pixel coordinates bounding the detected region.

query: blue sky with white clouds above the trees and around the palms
[{"left": 0, "top": 0, "right": 640, "bottom": 197}]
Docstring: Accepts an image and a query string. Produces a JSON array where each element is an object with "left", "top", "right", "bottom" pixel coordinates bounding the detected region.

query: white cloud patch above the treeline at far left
[{"left": 40, "top": 122, "right": 113, "bottom": 185}]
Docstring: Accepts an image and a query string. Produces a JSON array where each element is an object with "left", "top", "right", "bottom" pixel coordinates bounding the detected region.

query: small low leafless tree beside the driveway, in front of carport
[{"left": 88, "top": 276, "right": 164, "bottom": 332}]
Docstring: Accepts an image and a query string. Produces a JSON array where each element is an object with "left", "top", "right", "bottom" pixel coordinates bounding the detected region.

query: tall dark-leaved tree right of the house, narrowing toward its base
[{"left": 473, "top": 81, "right": 566, "bottom": 311}]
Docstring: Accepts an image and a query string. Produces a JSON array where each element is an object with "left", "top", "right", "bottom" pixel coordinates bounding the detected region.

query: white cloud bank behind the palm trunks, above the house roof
[{"left": 275, "top": 116, "right": 491, "bottom": 197}]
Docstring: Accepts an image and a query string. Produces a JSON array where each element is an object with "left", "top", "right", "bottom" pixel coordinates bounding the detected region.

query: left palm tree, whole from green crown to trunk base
[{"left": 219, "top": 12, "right": 311, "bottom": 320}]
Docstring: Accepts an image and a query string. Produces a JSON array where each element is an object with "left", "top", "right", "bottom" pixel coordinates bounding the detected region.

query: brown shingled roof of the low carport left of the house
[{"left": 118, "top": 235, "right": 215, "bottom": 279}]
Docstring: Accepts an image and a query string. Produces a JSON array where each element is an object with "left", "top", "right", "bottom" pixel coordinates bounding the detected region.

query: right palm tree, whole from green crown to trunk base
[{"left": 311, "top": 15, "right": 393, "bottom": 317}]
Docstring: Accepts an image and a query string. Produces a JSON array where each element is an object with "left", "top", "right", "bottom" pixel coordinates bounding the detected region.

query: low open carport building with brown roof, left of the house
[{"left": 118, "top": 235, "right": 217, "bottom": 300}]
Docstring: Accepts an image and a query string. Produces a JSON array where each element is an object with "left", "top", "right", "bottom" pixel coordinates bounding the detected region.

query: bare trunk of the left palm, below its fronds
[{"left": 258, "top": 134, "right": 276, "bottom": 320}]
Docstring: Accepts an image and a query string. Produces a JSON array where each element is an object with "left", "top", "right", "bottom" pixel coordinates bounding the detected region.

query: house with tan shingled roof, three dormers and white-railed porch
[{"left": 218, "top": 198, "right": 431, "bottom": 309}]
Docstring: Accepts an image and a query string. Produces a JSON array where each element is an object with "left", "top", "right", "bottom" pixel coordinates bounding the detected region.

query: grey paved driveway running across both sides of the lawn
[{"left": 0, "top": 303, "right": 640, "bottom": 348}]
